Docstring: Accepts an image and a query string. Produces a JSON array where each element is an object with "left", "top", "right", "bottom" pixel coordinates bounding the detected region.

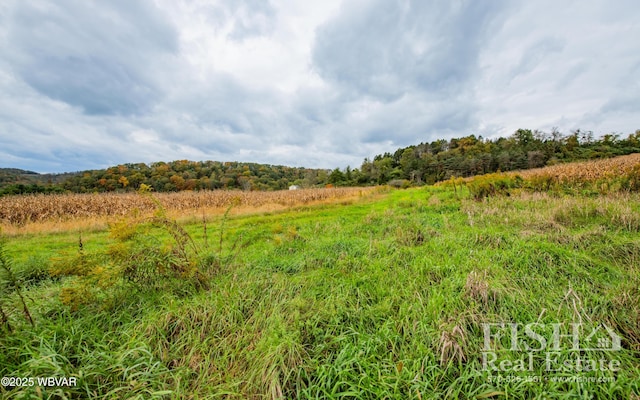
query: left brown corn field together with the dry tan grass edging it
[{"left": 0, "top": 188, "right": 374, "bottom": 235}]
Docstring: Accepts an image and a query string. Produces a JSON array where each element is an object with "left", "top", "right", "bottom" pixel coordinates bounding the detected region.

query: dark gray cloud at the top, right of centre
[{"left": 313, "top": 0, "right": 499, "bottom": 101}]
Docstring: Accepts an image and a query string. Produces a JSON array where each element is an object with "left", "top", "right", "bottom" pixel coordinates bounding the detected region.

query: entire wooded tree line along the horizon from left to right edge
[{"left": 0, "top": 128, "right": 640, "bottom": 195}]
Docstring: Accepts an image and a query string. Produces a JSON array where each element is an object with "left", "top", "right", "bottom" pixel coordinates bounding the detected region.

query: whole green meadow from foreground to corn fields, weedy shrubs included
[{"left": 0, "top": 161, "right": 640, "bottom": 399}]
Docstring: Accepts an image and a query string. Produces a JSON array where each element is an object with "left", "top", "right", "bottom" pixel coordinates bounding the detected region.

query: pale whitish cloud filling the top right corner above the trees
[{"left": 477, "top": 1, "right": 640, "bottom": 134}]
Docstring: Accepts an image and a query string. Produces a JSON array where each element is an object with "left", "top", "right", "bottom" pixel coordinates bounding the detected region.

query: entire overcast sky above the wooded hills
[{"left": 0, "top": 0, "right": 640, "bottom": 172}]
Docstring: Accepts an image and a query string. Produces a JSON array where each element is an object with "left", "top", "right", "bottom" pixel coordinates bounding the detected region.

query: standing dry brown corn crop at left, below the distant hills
[{"left": 0, "top": 188, "right": 371, "bottom": 225}]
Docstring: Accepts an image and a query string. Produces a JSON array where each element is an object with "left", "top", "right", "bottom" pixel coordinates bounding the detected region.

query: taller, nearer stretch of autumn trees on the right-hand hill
[{"left": 329, "top": 128, "right": 640, "bottom": 186}]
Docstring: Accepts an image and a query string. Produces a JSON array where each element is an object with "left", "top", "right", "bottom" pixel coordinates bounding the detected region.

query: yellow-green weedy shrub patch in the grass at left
[{"left": 51, "top": 206, "right": 209, "bottom": 310}]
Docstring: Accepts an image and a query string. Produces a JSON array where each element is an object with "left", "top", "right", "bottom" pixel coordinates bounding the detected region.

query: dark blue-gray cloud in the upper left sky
[{"left": 8, "top": 0, "right": 177, "bottom": 115}]
